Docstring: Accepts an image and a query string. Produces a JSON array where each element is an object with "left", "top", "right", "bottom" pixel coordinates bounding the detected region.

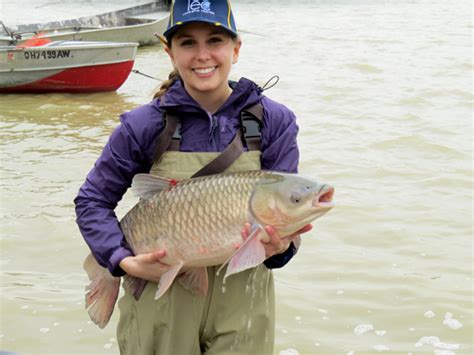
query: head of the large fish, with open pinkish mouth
[{"left": 250, "top": 173, "right": 334, "bottom": 235}]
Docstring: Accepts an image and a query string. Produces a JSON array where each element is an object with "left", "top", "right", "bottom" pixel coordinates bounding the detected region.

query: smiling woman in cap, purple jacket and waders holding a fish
[{"left": 75, "top": 0, "right": 311, "bottom": 354}]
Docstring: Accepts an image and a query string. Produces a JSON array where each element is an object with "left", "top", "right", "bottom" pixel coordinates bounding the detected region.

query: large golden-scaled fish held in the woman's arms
[{"left": 84, "top": 171, "right": 334, "bottom": 328}]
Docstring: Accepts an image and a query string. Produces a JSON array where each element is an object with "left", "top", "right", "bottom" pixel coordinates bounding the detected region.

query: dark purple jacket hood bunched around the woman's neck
[{"left": 153, "top": 78, "right": 262, "bottom": 115}]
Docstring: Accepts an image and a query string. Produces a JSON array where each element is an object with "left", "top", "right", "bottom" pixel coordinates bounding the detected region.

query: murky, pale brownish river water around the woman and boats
[{"left": 0, "top": 0, "right": 474, "bottom": 355}]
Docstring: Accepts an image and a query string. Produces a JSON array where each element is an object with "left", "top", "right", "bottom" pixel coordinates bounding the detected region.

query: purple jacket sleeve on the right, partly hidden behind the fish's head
[{"left": 262, "top": 98, "right": 299, "bottom": 269}]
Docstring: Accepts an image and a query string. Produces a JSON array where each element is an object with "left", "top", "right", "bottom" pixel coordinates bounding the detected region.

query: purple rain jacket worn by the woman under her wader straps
[{"left": 74, "top": 78, "right": 299, "bottom": 276}]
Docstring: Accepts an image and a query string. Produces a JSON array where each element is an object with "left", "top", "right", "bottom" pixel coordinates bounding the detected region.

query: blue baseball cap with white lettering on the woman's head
[{"left": 163, "top": 0, "right": 237, "bottom": 42}]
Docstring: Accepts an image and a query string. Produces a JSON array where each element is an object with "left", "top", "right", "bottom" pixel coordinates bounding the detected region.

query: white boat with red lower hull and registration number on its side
[{"left": 0, "top": 41, "right": 138, "bottom": 93}]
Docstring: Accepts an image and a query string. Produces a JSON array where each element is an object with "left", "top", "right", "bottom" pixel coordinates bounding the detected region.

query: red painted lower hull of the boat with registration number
[{"left": 0, "top": 60, "right": 134, "bottom": 93}]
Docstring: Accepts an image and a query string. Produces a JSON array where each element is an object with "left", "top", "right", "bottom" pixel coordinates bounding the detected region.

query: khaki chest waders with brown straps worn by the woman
[{"left": 117, "top": 105, "right": 275, "bottom": 355}]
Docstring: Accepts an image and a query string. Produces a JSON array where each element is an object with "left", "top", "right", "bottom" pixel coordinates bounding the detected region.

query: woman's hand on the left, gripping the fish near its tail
[{"left": 120, "top": 250, "right": 169, "bottom": 282}]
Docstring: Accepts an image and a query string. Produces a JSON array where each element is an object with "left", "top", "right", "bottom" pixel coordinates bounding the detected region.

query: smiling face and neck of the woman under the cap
[{"left": 166, "top": 22, "right": 241, "bottom": 97}]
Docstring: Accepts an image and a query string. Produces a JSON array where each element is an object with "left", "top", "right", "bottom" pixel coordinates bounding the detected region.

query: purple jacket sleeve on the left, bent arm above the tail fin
[{"left": 74, "top": 111, "right": 157, "bottom": 276}]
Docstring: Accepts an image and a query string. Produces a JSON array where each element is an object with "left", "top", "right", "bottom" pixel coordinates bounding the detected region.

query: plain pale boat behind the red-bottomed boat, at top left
[{"left": 0, "top": 1, "right": 169, "bottom": 45}]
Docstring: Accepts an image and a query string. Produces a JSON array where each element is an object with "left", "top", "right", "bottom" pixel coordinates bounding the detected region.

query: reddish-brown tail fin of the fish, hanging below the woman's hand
[{"left": 84, "top": 254, "right": 120, "bottom": 328}]
